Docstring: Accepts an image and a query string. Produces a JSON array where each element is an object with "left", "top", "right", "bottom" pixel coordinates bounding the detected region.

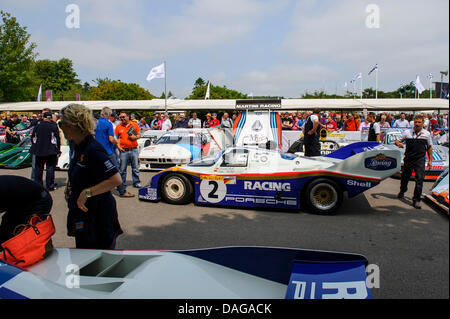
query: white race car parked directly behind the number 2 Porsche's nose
[{"left": 139, "top": 129, "right": 226, "bottom": 170}]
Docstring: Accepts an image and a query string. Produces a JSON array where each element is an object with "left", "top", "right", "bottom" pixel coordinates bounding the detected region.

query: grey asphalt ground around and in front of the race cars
[{"left": 0, "top": 168, "right": 449, "bottom": 299}]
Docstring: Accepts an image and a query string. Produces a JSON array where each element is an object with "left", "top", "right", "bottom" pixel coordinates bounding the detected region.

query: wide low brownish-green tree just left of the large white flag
[{"left": 90, "top": 78, "right": 155, "bottom": 100}]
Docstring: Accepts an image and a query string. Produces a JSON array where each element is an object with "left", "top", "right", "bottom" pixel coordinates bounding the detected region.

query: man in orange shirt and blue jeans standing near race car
[{"left": 114, "top": 112, "right": 142, "bottom": 197}]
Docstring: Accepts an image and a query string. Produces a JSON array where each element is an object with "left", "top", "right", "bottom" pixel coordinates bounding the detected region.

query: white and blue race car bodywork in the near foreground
[{"left": 0, "top": 247, "right": 371, "bottom": 299}]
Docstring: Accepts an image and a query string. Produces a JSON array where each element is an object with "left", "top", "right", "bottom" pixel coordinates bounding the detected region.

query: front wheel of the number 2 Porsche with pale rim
[{"left": 160, "top": 173, "right": 194, "bottom": 205}]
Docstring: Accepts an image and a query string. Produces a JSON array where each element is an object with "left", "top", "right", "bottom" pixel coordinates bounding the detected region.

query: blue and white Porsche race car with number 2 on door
[{"left": 139, "top": 142, "right": 401, "bottom": 214}]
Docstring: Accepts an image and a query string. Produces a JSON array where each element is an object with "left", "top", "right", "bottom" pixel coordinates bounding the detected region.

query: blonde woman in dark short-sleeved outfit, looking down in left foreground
[{"left": 59, "top": 104, "right": 122, "bottom": 249}]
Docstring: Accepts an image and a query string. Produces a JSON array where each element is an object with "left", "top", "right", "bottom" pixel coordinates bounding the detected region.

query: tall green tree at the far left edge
[{"left": 0, "top": 11, "right": 37, "bottom": 102}]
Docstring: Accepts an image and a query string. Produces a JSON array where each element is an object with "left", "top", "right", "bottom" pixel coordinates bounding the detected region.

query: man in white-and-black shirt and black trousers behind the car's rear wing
[{"left": 395, "top": 115, "right": 433, "bottom": 209}]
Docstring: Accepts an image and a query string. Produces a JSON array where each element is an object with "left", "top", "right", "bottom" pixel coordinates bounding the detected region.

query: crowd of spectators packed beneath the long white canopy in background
[{"left": 0, "top": 112, "right": 449, "bottom": 139}]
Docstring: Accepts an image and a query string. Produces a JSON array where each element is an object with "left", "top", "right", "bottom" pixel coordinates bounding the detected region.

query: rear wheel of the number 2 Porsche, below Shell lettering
[{"left": 303, "top": 178, "right": 344, "bottom": 215}]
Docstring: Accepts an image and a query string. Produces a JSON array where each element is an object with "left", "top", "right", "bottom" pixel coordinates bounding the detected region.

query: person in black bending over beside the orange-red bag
[{"left": 0, "top": 175, "right": 53, "bottom": 243}]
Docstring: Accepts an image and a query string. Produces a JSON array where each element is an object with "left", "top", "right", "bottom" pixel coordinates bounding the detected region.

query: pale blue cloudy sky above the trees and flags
[{"left": 0, "top": 0, "right": 449, "bottom": 98}]
